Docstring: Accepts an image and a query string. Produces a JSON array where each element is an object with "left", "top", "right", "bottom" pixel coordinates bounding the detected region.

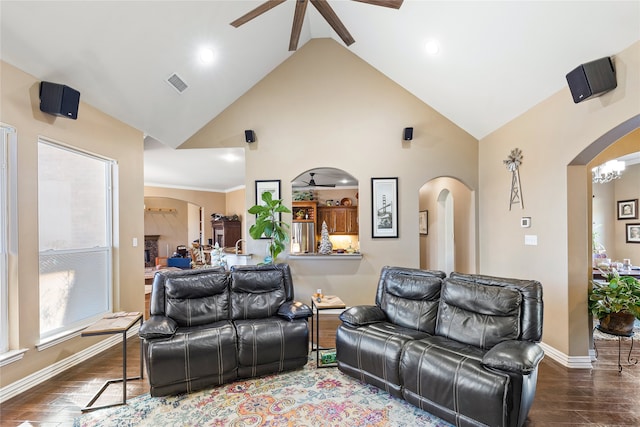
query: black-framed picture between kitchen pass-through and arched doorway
[{"left": 371, "top": 178, "right": 398, "bottom": 238}]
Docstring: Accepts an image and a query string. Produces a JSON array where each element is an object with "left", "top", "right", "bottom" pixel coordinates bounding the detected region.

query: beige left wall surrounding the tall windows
[{"left": 0, "top": 62, "right": 144, "bottom": 386}]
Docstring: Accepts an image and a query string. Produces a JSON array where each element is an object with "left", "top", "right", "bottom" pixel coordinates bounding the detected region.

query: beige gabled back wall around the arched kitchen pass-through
[{"left": 181, "top": 39, "right": 478, "bottom": 305}]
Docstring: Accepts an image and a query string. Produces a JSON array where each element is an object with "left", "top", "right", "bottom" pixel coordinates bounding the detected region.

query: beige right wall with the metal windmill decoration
[{"left": 479, "top": 43, "right": 640, "bottom": 361}]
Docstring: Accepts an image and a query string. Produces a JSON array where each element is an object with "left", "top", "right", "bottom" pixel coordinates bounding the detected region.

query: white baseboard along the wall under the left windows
[{"left": 0, "top": 325, "right": 140, "bottom": 403}]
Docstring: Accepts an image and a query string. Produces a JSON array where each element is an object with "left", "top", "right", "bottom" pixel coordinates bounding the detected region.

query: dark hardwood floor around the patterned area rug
[{"left": 0, "top": 338, "right": 640, "bottom": 427}]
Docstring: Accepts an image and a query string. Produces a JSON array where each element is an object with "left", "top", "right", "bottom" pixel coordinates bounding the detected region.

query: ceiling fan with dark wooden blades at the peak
[{"left": 231, "top": 0, "right": 404, "bottom": 51}]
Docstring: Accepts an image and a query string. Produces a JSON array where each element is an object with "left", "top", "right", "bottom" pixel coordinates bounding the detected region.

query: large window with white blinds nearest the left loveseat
[{"left": 38, "top": 139, "right": 113, "bottom": 340}]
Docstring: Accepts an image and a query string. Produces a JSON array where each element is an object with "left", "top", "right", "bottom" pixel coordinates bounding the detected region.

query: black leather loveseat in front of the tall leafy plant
[{"left": 139, "top": 264, "right": 311, "bottom": 396}]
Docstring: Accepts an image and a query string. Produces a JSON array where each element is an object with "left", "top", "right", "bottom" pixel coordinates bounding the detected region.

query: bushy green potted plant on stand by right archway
[{"left": 589, "top": 270, "right": 640, "bottom": 336}]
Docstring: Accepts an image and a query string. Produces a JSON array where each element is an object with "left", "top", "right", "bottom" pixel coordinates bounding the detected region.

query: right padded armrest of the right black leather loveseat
[{"left": 482, "top": 340, "right": 544, "bottom": 375}]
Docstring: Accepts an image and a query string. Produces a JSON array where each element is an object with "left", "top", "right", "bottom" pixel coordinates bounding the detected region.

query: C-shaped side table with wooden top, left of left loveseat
[{"left": 81, "top": 313, "right": 144, "bottom": 412}]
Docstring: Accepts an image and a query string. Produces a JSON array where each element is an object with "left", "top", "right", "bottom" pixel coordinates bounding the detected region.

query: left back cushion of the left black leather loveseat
[{"left": 164, "top": 271, "right": 229, "bottom": 326}]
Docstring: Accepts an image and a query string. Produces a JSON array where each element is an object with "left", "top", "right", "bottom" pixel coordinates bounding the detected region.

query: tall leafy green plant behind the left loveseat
[{"left": 249, "top": 191, "right": 291, "bottom": 264}]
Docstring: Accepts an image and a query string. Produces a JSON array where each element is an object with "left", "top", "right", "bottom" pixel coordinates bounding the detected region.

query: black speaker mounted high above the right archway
[{"left": 567, "top": 57, "right": 618, "bottom": 104}]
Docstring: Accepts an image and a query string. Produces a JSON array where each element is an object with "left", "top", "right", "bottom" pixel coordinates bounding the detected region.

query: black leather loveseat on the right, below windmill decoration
[{"left": 336, "top": 267, "right": 544, "bottom": 427}]
